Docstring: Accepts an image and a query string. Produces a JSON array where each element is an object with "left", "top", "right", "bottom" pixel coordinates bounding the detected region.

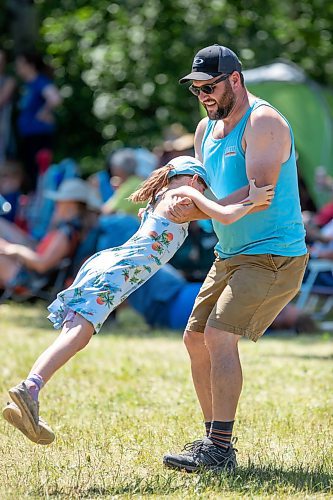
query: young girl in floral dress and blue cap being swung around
[{"left": 3, "top": 156, "right": 274, "bottom": 444}]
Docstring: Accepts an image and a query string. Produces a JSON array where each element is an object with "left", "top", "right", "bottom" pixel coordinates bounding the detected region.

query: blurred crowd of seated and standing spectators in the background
[{"left": 0, "top": 50, "right": 333, "bottom": 331}]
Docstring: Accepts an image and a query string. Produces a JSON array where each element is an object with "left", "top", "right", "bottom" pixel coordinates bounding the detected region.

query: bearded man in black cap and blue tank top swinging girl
[{"left": 164, "top": 45, "right": 308, "bottom": 471}]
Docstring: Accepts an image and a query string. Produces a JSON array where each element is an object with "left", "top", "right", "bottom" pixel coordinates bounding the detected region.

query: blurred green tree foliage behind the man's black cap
[{"left": 1, "top": 0, "right": 333, "bottom": 163}]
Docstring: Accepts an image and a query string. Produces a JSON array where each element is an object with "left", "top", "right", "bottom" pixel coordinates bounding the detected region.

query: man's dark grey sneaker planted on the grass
[{"left": 163, "top": 438, "right": 237, "bottom": 472}]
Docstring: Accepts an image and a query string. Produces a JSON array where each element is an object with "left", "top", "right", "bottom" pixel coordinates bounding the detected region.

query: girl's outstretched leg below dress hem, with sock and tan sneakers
[{"left": 4, "top": 312, "right": 94, "bottom": 444}]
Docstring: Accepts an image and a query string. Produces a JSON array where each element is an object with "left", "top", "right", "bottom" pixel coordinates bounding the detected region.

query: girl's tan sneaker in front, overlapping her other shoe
[{"left": 8, "top": 382, "right": 39, "bottom": 437}]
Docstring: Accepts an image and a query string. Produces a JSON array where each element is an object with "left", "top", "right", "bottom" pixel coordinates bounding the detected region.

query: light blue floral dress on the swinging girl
[{"left": 48, "top": 206, "right": 188, "bottom": 333}]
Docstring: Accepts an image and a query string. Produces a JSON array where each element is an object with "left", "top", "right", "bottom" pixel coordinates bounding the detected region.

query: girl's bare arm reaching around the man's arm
[{"left": 171, "top": 180, "right": 274, "bottom": 224}]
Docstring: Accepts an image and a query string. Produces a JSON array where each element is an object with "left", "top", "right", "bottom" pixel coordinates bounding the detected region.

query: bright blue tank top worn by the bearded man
[{"left": 202, "top": 99, "right": 307, "bottom": 258}]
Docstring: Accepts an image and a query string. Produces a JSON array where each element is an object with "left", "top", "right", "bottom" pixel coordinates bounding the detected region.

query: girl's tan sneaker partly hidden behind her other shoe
[{"left": 2, "top": 403, "right": 55, "bottom": 445}]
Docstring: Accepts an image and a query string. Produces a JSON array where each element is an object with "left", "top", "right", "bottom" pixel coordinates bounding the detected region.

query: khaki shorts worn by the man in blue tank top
[{"left": 186, "top": 254, "right": 309, "bottom": 341}]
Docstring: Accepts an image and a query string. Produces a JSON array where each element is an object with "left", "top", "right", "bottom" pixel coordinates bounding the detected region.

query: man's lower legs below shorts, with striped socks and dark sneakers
[{"left": 164, "top": 327, "right": 243, "bottom": 471}]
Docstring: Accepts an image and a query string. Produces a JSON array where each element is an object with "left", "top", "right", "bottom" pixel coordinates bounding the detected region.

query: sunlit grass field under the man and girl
[{"left": 0, "top": 305, "right": 333, "bottom": 500}]
